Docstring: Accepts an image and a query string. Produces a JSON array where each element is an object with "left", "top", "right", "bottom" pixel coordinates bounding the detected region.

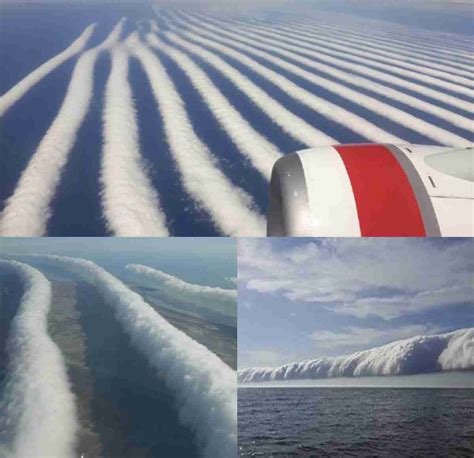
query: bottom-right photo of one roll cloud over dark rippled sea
[{"left": 238, "top": 238, "right": 474, "bottom": 457}]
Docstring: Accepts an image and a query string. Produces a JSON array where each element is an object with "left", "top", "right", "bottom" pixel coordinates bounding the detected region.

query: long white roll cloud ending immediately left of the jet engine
[{"left": 127, "top": 36, "right": 265, "bottom": 236}]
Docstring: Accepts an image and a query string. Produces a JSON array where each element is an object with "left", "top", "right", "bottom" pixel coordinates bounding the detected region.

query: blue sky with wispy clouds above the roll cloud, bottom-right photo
[{"left": 238, "top": 238, "right": 474, "bottom": 368}]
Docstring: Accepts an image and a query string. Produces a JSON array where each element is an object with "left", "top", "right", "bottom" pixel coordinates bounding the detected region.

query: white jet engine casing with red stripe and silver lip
[{"left": 267, "top": 144, "right": 474, "bottom": 237}]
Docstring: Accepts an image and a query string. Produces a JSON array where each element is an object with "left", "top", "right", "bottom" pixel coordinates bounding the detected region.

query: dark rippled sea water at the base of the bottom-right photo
[{"left": 238, "top": 388, "right": 474, "bottom": 457}]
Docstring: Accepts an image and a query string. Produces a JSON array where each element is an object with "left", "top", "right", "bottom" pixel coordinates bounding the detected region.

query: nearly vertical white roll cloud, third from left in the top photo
[{"left": 100, "top": 39, "right": 169, "bottom": 237}]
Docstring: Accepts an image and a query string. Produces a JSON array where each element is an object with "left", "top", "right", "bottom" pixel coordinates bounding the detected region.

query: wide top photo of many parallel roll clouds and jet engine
[{"left": 0, "top": 0, "right": 474, "bottom": 237}]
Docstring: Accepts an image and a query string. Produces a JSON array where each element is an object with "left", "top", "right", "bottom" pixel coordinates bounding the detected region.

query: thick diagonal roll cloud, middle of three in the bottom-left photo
[{"left": 41, "top": 256, "right": 237, "bottom": 457}]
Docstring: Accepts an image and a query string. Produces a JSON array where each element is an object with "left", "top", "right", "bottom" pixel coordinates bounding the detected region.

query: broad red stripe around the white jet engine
[{"left": 335, "top": 145, "right": 426, "bottom": 237}]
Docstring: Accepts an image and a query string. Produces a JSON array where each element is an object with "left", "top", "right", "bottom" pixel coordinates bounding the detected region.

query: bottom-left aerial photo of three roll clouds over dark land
[{"left": 0, "top": 238, "right": 237, "bottom": 458}]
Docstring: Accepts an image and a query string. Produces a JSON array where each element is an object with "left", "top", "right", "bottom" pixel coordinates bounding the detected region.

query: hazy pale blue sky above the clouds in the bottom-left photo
[{"left": 0, "top": 237, "right": 237, "bottom": 288}]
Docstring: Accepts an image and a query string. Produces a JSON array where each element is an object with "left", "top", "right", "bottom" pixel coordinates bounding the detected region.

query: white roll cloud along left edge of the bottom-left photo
[{"left": 0, "top": 261, "right": 79, "bottom": 458}]
